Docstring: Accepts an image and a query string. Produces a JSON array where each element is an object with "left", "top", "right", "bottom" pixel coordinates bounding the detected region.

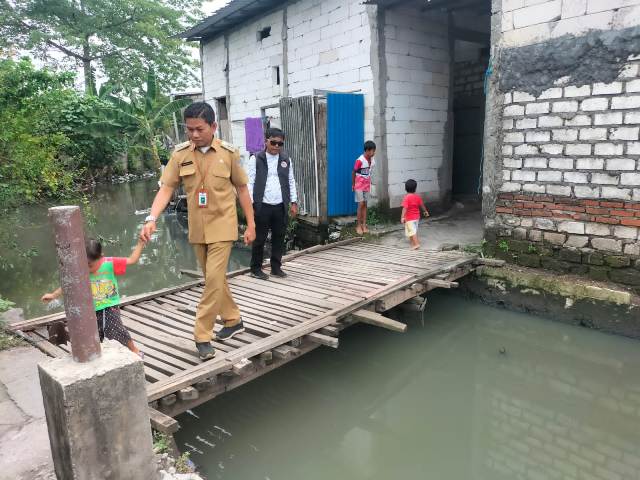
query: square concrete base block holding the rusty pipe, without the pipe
[{"left": 38, "top": 340, "right": 158, "bottom": 480}]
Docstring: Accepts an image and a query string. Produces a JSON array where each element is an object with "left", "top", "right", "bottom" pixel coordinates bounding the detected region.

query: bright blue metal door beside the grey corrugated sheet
[{"left": 327, "top": 93, "right": 364, "bottom": 217}]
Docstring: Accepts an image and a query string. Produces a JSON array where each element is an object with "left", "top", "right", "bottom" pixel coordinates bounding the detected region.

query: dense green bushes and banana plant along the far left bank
[{"left": 0, "top": 58, "right": 180, "bottom": 208}]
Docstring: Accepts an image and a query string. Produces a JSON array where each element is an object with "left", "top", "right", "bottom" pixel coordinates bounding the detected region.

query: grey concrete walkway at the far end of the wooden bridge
[{"left": 376, "top": 210, "right": 483, "bottom": 250}]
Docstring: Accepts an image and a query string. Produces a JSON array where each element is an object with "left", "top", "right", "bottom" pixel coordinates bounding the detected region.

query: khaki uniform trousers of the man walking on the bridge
[{"left": 193, "top": 242, "right": 240, "bottom": 342}]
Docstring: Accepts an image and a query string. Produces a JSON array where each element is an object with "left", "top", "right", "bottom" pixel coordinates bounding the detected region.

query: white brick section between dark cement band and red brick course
[{"left": 501, "top": 61, "right": 640, "bottom": 200}]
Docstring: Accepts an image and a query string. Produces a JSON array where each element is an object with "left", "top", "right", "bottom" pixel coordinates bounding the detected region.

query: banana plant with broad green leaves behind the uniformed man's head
[{"left": 84, "top": 71, "right": 191, "bottom": 170}]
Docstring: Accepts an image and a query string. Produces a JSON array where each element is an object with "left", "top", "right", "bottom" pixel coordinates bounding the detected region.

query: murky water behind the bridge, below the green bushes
[{"left": 0, "top": 179, "right": 250, "bottom": 318}]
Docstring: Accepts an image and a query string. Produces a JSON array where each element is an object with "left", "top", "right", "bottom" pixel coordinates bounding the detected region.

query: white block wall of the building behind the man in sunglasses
[{"left": 202, "top": 0, "right": 374, "bottom": 162}]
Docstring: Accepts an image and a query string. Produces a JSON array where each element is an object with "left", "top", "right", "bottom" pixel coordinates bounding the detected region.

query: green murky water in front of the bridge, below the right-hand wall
[{"left": 177, "top": 293, "right": 640, "bottom": 480}]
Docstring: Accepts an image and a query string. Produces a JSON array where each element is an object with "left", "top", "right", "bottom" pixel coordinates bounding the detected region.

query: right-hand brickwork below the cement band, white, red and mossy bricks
[{"left": 488, "top": 61, "right": 640, "bottom": 286}]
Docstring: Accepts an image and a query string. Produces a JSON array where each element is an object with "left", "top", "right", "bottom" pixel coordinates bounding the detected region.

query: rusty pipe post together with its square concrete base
[{"left": 38, "top": 207, "right": 158, "bottom": 480}]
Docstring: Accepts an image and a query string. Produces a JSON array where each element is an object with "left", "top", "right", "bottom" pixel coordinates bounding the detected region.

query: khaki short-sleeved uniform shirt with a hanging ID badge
[{"left": 160, "top": 138, "right": 248, "bottom": 243}]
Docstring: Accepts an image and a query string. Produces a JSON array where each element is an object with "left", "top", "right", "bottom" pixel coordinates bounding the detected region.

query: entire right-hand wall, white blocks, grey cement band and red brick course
[{"left": 484, "top": 0, "right": 640, "bottom": 287}]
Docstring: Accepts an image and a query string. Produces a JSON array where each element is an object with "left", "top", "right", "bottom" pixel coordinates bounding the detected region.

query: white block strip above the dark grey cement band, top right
[{"left": 496, "top": 0, "right": 640, "bottom": 47}]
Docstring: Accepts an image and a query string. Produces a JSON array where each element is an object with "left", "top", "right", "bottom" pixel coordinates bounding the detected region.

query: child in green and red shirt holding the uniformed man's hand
[{"left": 42, "top": 238, "right": 144, "bottom": 357}]
